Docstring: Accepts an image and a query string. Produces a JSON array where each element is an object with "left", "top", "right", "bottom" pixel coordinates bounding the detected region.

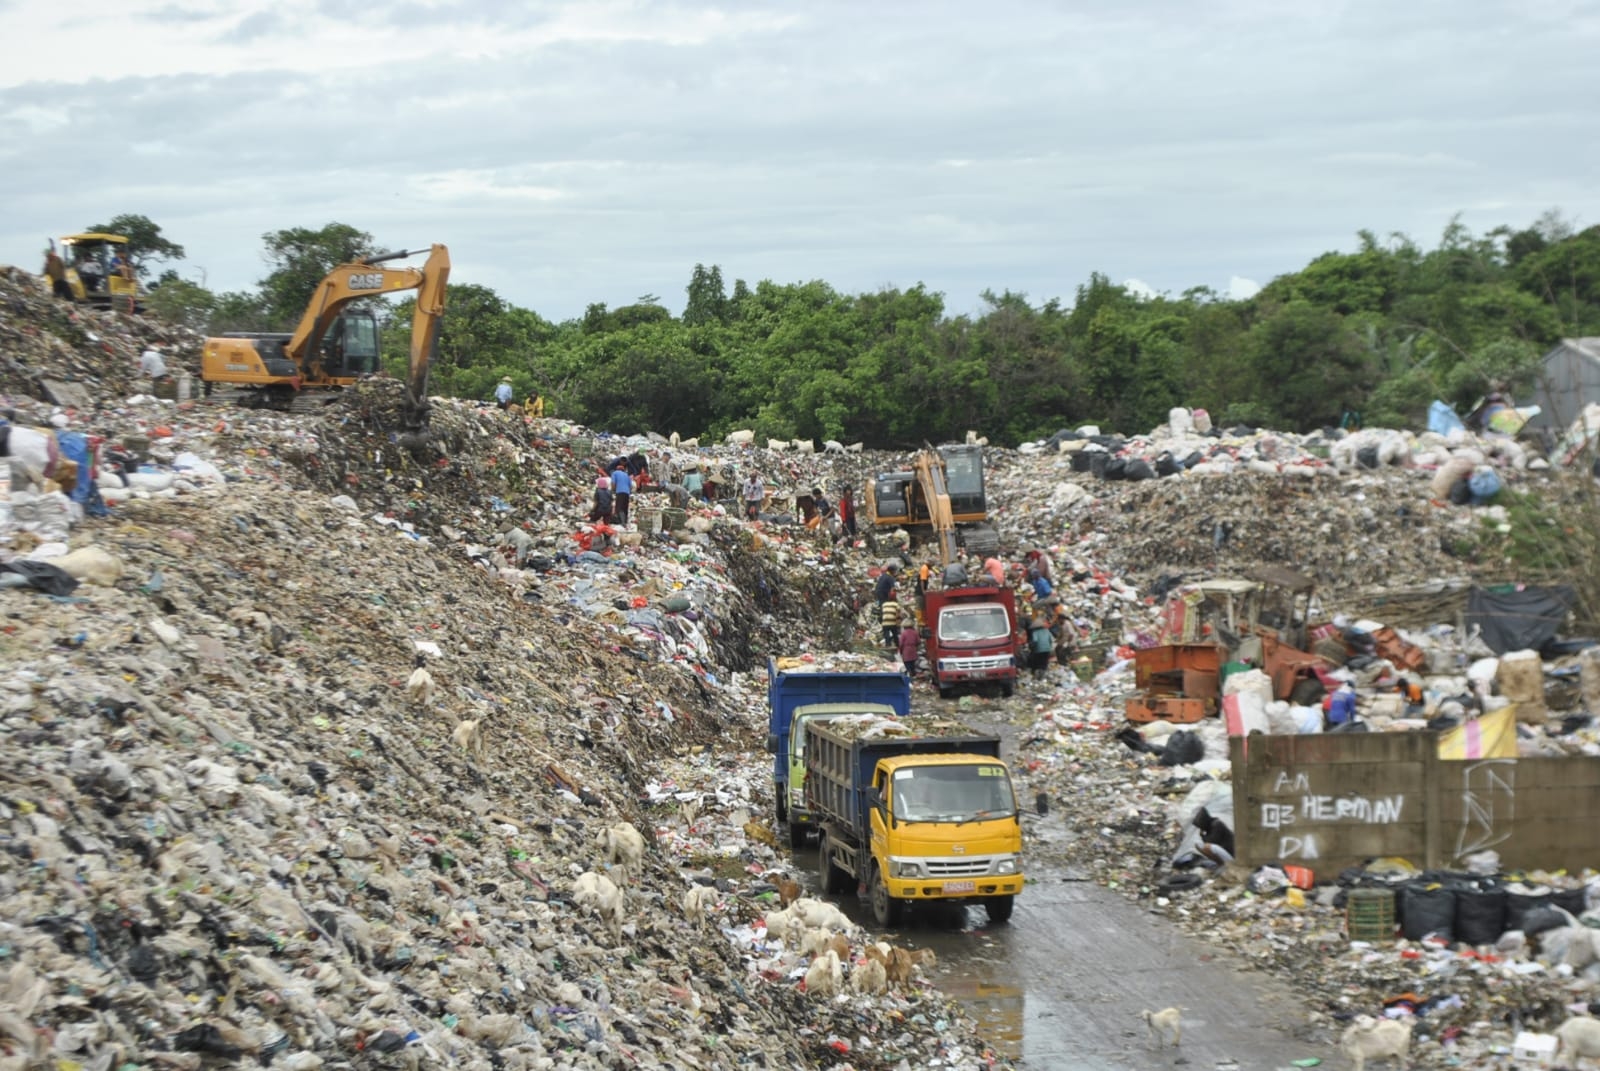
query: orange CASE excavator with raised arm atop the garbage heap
[{"left": 200, "top": 245, "right": 450, "bottom": 431}]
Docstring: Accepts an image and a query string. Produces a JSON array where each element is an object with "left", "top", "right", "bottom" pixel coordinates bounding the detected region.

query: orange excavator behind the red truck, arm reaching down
[{"left": 867, "top": 443, "right": 1000, "bottom": 565}]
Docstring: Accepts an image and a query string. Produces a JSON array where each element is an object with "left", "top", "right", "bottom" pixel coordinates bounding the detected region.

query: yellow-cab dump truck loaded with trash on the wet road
[{"left": 805, "top": 714, "right": 1024, "bottom": 927}]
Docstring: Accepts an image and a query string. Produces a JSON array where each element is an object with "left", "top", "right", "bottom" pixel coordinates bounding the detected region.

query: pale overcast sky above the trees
[{"left": 0, "top": 0, "right": 1600, "bottom": 320}]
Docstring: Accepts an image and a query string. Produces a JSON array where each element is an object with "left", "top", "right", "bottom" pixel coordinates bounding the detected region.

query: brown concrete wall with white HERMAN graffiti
[{"left": 1232, "top": 733, "right": 1600, "bottom": 879}]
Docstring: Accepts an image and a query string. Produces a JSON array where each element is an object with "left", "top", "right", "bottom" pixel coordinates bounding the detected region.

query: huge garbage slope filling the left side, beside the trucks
[{"left": 0, "top": 306, "right": 1017, "bottom": 1071}]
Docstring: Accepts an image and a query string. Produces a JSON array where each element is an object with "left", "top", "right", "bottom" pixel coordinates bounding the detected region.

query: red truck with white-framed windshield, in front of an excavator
[{"left": 923, "top": 588, "right": 1022, "bottom": 698}]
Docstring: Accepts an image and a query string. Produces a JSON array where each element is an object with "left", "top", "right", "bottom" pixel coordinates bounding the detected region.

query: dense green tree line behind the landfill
[{"left": 114, "top": 211, "right": 1600, "bottom": 447}]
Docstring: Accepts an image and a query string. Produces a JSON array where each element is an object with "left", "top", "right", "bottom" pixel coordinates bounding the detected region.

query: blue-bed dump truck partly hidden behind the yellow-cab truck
[{"left": 766, "top": 656, "right": 910, "bottom": 848}]
